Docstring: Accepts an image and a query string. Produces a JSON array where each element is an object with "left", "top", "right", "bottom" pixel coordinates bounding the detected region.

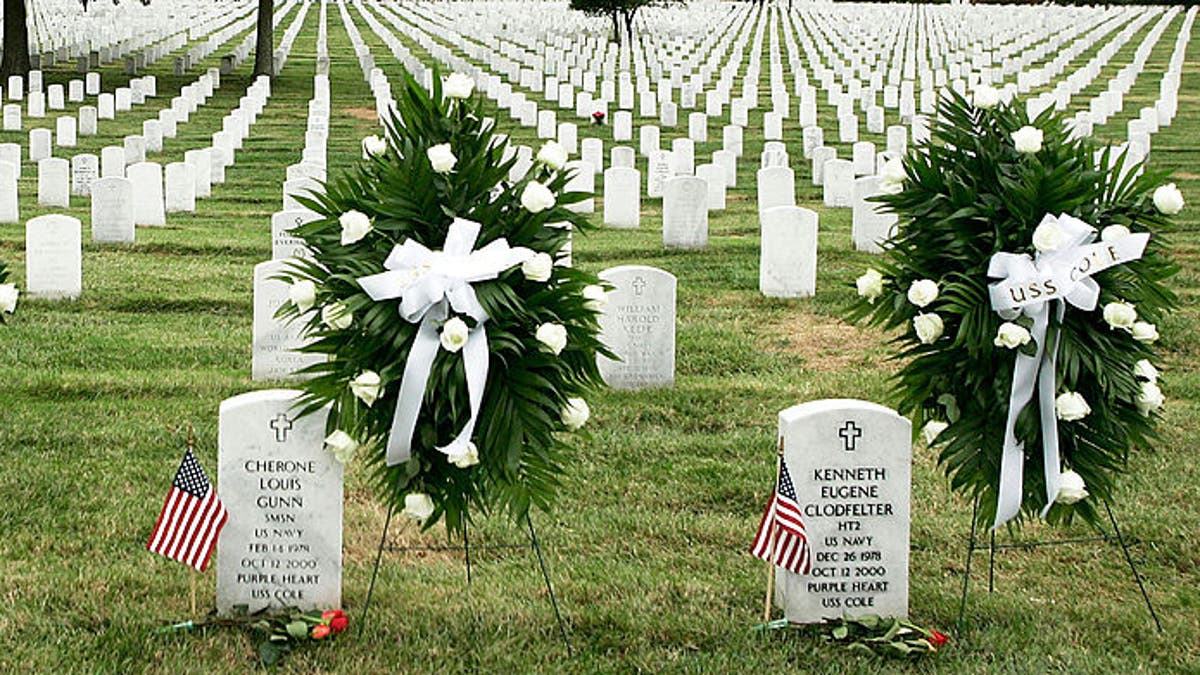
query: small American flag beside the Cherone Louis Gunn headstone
[{"left": 146, "top": 448, "right": 229, "bottom": 572}]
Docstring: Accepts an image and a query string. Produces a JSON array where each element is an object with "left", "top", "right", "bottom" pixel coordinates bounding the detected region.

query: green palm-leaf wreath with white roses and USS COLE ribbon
[{"left": 848, "top": 86, "right": 1183, "bottom": 526}]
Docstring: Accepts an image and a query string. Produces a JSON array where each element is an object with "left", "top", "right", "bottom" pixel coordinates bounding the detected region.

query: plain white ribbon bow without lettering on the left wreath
[{"left": 358, "top": 219, "right": 534, "bottom": 466}]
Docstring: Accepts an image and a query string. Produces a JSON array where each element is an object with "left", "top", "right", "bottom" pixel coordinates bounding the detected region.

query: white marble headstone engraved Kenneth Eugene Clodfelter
[{"left": 772, "top": 399, "right": 912, "bottom": 623}]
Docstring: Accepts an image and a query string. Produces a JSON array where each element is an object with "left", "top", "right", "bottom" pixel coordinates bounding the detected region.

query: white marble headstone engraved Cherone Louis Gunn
[{"left": 217, "top": 389, "right": 343, "bottom": 615}]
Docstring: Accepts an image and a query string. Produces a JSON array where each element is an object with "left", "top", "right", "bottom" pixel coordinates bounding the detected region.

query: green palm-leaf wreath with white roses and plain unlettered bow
[{"left": 281, "top": 73, "right": 607, "bottom": 531}]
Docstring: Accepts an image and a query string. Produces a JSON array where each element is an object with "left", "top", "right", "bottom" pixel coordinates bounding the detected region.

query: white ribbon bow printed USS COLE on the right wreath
[{"left": 988, "top": 214, "right": 1150, "bottom": 527}]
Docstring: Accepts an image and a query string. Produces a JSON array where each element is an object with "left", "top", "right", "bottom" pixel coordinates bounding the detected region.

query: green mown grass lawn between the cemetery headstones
[{"left": 0, "top": 5, "right": 1200, "bottom": 673}]
